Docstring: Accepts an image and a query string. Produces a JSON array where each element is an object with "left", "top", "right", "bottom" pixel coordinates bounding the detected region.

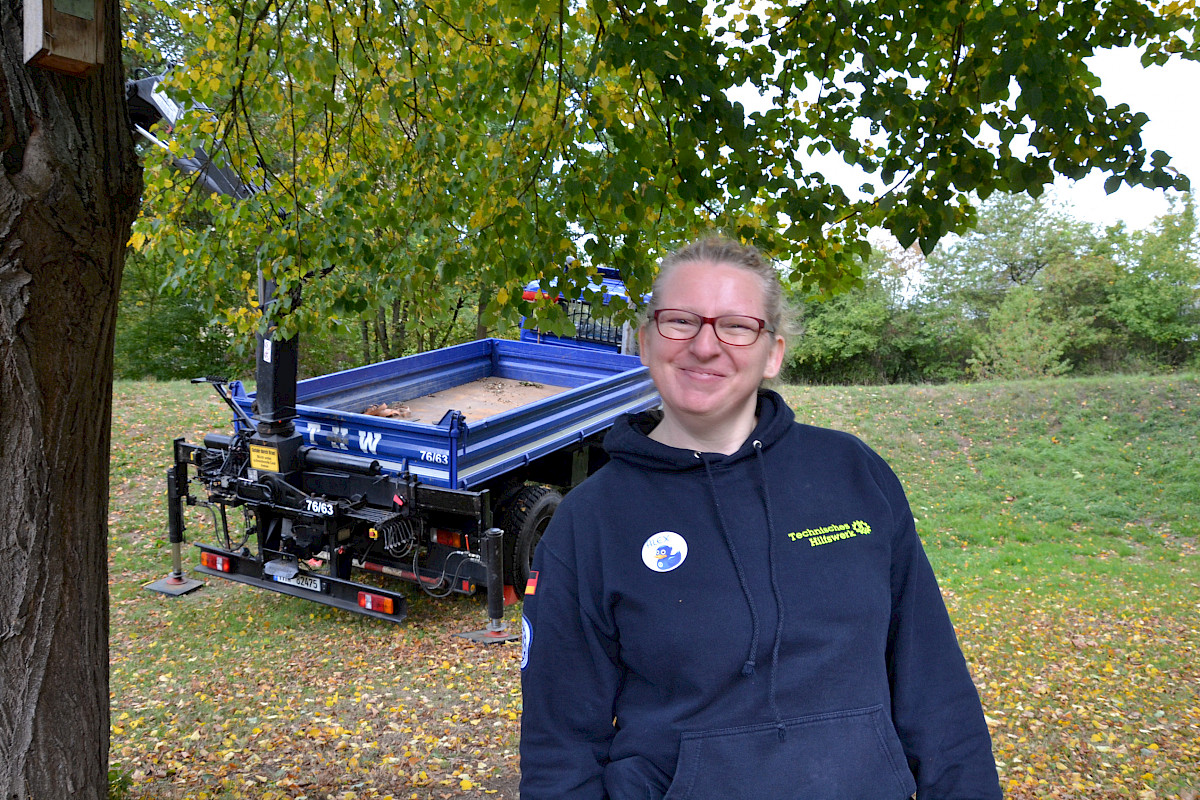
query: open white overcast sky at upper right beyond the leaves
[{"left": 1054, "top": 48, "right": 1200, "bottom": 228}]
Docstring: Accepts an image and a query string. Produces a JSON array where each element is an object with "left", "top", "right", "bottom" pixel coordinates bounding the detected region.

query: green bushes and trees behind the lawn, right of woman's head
[{"left": 785, "top": 194, "right": 1200, "bottom": 384}]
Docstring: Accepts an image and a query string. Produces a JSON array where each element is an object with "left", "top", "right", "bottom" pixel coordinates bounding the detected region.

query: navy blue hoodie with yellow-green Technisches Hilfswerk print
[{"left": 521, "top": 392, "right": 1001, "bottom": 800}]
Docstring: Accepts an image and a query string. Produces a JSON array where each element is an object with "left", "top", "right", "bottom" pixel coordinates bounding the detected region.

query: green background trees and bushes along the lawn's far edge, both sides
[{"left": 116, "top": 189, "right": 1200, "bottom": 384}]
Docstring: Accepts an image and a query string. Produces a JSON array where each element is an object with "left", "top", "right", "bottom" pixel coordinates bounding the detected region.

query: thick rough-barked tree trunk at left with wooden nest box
[{"left": 0, "top": 0, "right": 142, "bottom": 800}]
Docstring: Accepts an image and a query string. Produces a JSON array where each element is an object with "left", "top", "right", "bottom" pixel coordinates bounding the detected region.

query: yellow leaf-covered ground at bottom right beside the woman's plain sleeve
[{"left": 955, "top": 589, "right": 1200, "bottom": 800}]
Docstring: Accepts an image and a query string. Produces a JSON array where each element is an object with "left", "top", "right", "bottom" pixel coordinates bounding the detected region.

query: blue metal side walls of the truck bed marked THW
[{"left": 234, "top": 339, "right": 659, "bottom": 489}]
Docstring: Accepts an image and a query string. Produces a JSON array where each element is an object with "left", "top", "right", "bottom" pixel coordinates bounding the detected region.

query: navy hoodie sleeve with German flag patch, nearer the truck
[{"left": 521, "top": 507, "right": 620, "bottom": 800}]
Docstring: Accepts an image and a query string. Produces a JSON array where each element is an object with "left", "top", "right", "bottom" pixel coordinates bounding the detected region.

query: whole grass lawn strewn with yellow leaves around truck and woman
[{"left": 109, "top": 375, "right": 1200, "bottom": 800}]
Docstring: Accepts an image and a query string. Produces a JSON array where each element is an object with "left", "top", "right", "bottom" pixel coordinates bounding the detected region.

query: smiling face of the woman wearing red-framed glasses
[{"left": 638, "top": 261, "right": 784, "bottom": 426}]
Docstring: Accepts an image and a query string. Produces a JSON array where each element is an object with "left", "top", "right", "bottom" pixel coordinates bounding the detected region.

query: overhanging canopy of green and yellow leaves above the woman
[{"left": 126, "top": 0, "right": 1200, "bottom": 333}]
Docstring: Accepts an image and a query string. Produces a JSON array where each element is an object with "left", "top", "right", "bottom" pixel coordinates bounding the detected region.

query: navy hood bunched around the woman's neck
[{"left": 604, "top": 389, "right": 796, "bottom": 473}]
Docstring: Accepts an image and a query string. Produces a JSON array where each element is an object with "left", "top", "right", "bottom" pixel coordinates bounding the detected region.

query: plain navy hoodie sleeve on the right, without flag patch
[{"left": 884, "top": 460, "right": 1002, "bottom": 800}]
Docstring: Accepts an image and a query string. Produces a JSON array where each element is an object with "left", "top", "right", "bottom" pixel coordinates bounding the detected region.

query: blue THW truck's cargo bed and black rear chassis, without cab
[{"left": 167, "top": 337, "right": 659, "bottom": 621}]
